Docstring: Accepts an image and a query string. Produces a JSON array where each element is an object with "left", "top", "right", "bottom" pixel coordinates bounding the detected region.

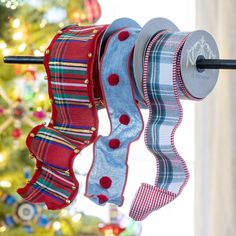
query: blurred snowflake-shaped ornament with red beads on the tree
[{"left": 0, "top": 71, "right": 49, "bottom": 148}]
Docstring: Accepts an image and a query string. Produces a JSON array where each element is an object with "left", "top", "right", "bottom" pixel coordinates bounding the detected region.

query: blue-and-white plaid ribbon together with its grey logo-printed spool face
[{"left": 130, "top": 27, "right": 219, "bottom": 221}]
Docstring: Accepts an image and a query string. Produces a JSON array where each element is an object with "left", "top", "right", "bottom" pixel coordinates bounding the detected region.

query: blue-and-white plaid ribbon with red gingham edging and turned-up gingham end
[{"left": 130, "top": 32, "right": 192, "bottom": 220}]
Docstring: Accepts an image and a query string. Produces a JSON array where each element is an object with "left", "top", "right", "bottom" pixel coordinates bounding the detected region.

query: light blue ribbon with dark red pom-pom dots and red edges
[{"left": 85, "top": 28, "right": 143, "bottom": 206}]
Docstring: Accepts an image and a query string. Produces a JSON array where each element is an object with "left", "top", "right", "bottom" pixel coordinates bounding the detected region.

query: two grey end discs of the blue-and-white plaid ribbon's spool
[{"left": 133, "top": 18, "right": 219, "bottom": 101}]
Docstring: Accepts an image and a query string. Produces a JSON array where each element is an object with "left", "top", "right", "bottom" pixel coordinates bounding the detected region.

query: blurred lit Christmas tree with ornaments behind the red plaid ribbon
[{"left": 0, "top": 0, "right": 101, "bottom": 236}]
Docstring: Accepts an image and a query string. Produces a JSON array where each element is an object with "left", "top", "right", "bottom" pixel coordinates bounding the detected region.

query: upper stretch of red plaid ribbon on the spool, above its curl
[{"left": 49, "top": 26, "right": 104, "bottom": 148}]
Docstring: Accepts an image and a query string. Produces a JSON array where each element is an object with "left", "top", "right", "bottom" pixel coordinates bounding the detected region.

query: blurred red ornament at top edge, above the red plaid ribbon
[{"left": 84, "top": 0, "right": 101, "bottom": 23}]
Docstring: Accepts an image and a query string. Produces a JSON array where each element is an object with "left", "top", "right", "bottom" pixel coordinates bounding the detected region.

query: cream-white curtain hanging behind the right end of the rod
[{"left": 195, "top": 0, "right": 236, "bottom": 236}]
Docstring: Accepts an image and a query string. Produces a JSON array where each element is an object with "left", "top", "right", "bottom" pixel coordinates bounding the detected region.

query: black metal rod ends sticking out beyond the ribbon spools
[{"left": 3, "top": 56, "right": 236, "bottom": 70}]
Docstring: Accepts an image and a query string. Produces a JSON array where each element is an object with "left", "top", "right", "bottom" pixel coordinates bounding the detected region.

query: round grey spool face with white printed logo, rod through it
[{"left": 180, "top": 30, "right": 219, "bottom": 99}]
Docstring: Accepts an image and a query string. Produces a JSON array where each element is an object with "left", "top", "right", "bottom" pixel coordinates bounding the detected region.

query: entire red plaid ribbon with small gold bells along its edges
[{"left": 18, "top": 25, "right": 106, "bottom": 210}]
